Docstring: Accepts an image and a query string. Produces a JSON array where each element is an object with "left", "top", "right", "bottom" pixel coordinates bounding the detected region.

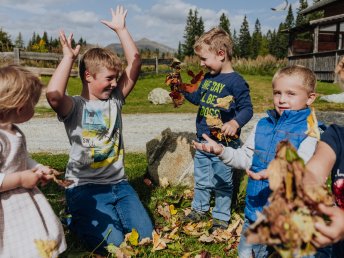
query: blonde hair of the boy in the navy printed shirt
[{"left": 193, "top": 27, "right": 233, "bottom": 60}]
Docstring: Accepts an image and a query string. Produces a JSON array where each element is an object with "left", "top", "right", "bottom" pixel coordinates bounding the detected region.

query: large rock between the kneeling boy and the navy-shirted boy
[{"left": 146, "top": 128, "right": 196, "bottom": 187}]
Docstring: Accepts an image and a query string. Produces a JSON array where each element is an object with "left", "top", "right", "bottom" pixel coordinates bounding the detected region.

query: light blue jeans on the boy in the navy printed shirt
[{"left": 192, "top": 138, "right": 239, "bottom": 221}]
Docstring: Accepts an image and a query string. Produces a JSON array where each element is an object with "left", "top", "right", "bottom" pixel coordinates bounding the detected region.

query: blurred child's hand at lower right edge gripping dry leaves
[{"left": 312, "top": 204, "right": 344, "bottom": 248}]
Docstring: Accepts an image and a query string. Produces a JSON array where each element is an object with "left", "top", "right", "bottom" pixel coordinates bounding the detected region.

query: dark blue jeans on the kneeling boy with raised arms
[{"left": 66, "top": 181, "right": 153, "bottom": 254}]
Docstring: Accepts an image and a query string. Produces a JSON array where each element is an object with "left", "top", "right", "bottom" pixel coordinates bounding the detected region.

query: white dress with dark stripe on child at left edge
[{"left": 0, "top": 127, "right": 66, "bottom": 258}]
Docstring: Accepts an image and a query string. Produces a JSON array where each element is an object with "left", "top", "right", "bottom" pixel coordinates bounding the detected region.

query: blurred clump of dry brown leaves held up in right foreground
[{"left": 247, "top": 141, "right": 333, "bottom": 258}]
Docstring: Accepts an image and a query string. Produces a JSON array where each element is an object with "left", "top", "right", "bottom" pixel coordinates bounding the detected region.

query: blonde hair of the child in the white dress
[{"left": 0, "top": 65, "right": 43, "bottom": 115}]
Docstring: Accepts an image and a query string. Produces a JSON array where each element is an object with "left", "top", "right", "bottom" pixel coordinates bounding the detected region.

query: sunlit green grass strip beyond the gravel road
[{"left": 36, "top": 71, "right": 344, "bottom": 116}]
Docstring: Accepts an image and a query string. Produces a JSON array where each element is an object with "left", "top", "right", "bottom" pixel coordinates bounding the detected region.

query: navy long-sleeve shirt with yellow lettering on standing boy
[{"left": 183, "top": 72, "right": 253, "bottom": 141}]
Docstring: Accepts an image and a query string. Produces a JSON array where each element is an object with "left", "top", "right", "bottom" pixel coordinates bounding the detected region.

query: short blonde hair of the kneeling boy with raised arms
[{"left": 79, "top": 47, "right": 122, "bottom": 80}]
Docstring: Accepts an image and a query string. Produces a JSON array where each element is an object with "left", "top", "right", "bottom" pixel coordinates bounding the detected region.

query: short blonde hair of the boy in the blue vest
[{"left": 272, "top": 65, "right": 317, "bottom": 93}]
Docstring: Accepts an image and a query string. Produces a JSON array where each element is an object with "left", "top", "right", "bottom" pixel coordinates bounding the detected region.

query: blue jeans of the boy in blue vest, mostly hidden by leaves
[{"left": 238, "top": 218, "right": 274, "bottom": 258}]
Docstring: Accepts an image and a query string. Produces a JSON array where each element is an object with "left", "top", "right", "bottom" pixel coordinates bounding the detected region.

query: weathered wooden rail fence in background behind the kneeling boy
[{"left": 13, "top": 48, "right": 172, "bottom": 77}]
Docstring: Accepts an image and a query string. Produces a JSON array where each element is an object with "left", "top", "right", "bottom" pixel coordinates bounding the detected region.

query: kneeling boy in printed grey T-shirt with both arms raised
[{"left": 47, "top": 6, "right": 153, "bottom": 254}]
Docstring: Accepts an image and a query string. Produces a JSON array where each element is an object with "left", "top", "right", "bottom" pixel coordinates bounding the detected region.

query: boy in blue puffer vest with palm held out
[{"left": 194, "top": 66, "right": 326, "bottom": 258}]
